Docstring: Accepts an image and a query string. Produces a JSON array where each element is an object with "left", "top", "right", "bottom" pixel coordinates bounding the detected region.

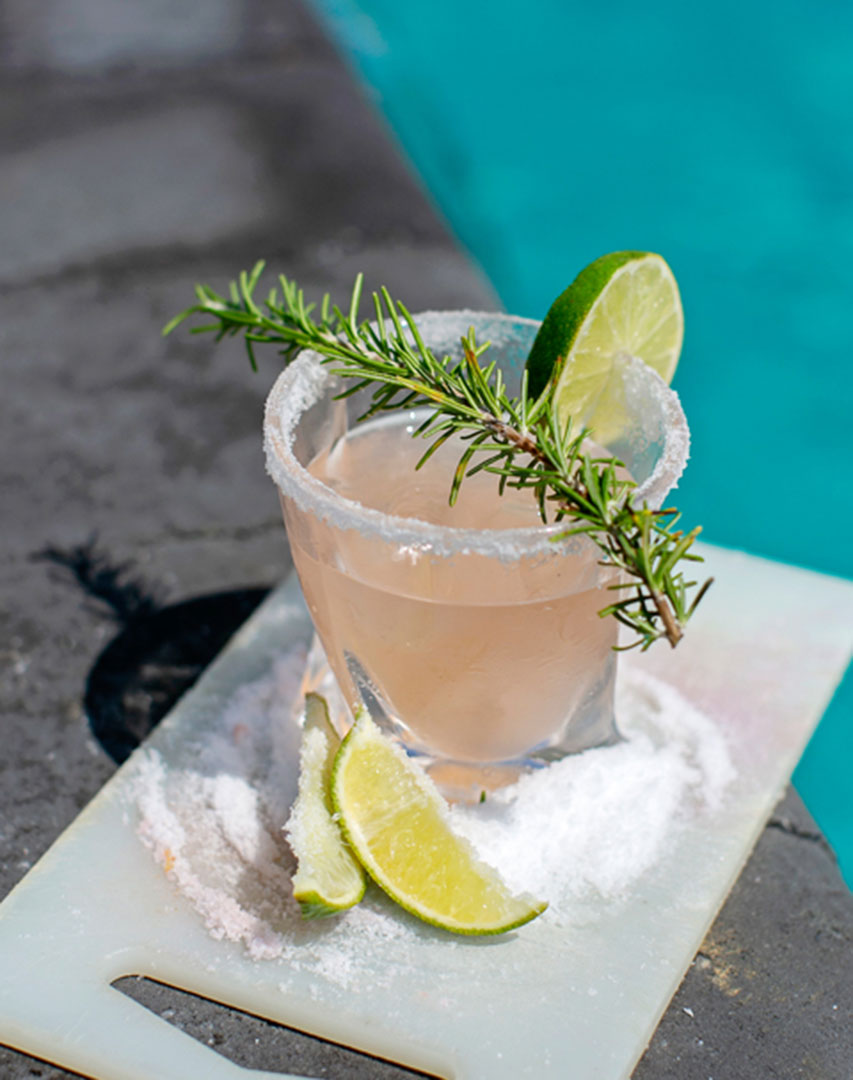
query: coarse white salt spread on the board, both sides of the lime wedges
[{"left": 125, "top": 650, "right": 734, "bottom": 987}]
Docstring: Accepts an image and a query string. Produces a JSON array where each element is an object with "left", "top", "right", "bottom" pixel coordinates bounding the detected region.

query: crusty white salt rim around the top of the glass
[{"left": 263, "top": 310, "right": 690, "bottom": 562}]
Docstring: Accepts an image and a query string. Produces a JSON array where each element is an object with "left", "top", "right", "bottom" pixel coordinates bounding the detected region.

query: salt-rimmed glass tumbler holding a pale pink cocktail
[{"left": 265, "top": 311, "right": 689, "bottom": 796}]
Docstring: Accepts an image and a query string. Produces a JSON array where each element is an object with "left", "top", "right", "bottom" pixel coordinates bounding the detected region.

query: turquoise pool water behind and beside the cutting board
[{"left": 314, "top": 0, "right": 853, "bottom": 885}]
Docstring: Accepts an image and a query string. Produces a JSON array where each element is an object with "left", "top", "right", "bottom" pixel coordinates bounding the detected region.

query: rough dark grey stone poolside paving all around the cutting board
[{"left": 0, "top": 0, "right": 853, "bottom": 1080}]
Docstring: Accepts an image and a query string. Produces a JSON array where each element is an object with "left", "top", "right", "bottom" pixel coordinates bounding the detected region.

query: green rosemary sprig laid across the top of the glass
[{"left": 163, "top": 262, "right": 713, "bottom": 650}]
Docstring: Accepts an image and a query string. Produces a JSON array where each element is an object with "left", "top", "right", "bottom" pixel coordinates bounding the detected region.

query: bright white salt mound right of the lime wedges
[{"left": 452, "top": 667, "right": 734, "bottom": 922}]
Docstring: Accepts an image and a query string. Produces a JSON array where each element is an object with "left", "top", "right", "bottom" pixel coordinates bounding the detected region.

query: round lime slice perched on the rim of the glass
[{"left": 527, "top": 252, "right": 685, "bottom": 445}]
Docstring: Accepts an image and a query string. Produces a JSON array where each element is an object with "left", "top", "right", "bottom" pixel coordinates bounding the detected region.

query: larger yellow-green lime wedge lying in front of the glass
[{"left": 331, "top": 713, "right": 547, "bottom": 934}]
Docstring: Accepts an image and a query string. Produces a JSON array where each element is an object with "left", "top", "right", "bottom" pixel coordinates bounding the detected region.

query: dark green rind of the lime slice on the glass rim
[{"left": 526, "top": 252, "right": 650, "bottom": 397}]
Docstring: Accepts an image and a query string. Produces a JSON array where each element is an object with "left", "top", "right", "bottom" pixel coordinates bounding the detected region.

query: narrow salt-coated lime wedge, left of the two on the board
[{"left": 285, "top": 693, "right": 365, "bottom": 919}]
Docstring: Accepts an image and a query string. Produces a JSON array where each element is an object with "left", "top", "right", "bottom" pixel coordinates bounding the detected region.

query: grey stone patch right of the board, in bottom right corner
[{"left": 634, "top": 789, "right": 853, "bottom": 1080}]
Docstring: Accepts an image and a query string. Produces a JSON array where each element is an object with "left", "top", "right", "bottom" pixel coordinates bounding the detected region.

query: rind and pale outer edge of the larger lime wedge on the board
[{"left": 330, "top": 714, "right": 547, "bottom": 937}]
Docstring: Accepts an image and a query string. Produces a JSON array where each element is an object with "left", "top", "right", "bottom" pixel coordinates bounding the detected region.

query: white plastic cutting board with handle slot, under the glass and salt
[{"left": 0, "top": 546, "right": 853, "bottom": 1080}]
